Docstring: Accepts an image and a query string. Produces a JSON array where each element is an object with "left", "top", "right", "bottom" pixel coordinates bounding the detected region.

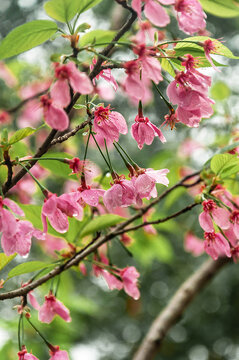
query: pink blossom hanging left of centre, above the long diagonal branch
[{"left": 42, "top": 192, "right": 83, "bottom": 233}]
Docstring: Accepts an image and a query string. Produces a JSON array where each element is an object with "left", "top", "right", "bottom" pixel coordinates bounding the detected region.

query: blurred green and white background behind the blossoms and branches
[{"left": 0, "top": 0, "right": 239, "bottom": 360}]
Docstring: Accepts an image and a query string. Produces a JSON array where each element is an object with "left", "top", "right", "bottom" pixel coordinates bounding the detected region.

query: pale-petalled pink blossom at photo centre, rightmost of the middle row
[{"left": 132, "top": 168, "right": 169, "bottom": 206}]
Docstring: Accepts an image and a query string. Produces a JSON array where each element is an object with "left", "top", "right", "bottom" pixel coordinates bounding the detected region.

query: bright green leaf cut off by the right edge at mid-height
[{"left": 210, "top": 154, "right": 239, "bottom": 178}]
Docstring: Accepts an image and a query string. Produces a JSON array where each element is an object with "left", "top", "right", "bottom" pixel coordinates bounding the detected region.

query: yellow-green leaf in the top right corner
[{"left": 199, "top": 0, "right": 239, "bottom": 18}]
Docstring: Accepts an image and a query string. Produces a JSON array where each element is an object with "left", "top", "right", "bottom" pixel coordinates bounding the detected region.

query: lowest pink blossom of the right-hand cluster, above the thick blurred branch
[{"left": 203, "top": 231, "right": 231, "bottom": 260}]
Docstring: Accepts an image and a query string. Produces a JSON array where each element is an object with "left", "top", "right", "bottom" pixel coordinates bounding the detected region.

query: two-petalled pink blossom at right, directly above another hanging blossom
[{"left": 199, "top": 200, "right": 230, "bottom": 232}]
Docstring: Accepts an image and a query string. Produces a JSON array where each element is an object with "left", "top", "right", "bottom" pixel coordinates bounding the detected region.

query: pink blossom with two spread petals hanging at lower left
[{"left": 38, "top": 291, "right": 71, "bottom": 324}]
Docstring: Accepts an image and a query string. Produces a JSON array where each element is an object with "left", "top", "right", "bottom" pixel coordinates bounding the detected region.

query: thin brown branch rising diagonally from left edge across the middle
[{"left": 0, "top": 172, "right": 202, "bottom": 300}]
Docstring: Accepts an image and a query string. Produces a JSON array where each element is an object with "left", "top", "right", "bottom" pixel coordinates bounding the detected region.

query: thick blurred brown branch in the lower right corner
[{"left": 133, "top": 258, "right": 231, "bottom": 360}]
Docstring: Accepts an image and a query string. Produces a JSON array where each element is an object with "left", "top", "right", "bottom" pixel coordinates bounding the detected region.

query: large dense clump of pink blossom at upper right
[{"left": 167, "top": 56, "right": 214, "bottom": 127}]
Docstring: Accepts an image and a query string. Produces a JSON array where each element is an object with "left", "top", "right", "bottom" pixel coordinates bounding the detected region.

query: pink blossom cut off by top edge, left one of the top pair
[{"left": 132, "top": 0, "right": 175, "bottom": 27}]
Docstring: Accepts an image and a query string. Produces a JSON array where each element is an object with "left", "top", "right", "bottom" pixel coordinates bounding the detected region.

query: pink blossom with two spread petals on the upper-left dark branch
[{"left": 50, "top": 62, "right": 93, "bottom": 107}]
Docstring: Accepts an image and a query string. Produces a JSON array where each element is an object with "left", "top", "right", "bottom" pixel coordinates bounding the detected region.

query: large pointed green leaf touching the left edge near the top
[{"left": 0, "top": 20, "right": 57, "bottom": 59}]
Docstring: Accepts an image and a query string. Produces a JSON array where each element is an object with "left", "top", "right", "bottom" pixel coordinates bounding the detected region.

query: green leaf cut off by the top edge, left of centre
[{"left": 44, "top": 0, "right": 102, "bottom": 23}]
